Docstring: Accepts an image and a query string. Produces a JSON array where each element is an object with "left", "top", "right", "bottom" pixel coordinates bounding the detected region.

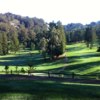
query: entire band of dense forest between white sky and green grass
[{"left": 0, "top": 13, "right": 100, "bottom": 59}]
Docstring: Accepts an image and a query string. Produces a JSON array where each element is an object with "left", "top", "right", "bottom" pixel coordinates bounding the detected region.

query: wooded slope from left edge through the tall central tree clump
[{"left": 0, "top": 13, "right": 66, "bottom": 59}]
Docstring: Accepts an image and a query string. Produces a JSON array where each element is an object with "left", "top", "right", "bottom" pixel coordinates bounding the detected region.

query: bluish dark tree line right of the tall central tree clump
[{"left": 64, "top": 21, "right": 100, "bottom": 52}]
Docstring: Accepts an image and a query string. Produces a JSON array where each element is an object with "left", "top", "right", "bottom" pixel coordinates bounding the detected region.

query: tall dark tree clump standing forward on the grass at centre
[{"left": 47, "top": 22, "right": 66, "bottom": 59}]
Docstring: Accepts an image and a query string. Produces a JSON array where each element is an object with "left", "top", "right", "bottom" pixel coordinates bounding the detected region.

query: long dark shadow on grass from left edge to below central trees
[{"left": 0, "top": 54, "right": 65, "bottom": 68}]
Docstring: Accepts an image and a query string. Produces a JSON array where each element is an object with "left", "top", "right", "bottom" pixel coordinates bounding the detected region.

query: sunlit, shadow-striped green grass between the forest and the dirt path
[{"left": 0, "top": 43, "right": 100, "bottom": 75}]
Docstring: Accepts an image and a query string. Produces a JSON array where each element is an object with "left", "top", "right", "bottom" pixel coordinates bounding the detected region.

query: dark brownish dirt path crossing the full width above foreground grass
[{"left": 0, "top": 75, "right": 100, "bottom": 84}]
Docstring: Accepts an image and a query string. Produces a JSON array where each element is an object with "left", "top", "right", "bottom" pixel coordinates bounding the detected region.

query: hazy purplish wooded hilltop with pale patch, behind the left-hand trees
[{"left": 0, "top": 13, "right": 47, "bottom": 32}]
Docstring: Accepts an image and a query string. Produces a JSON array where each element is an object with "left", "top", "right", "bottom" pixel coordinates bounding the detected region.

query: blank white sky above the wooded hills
[{"left": 0, "top": 0, "right": 100, "bottom": 24}]
